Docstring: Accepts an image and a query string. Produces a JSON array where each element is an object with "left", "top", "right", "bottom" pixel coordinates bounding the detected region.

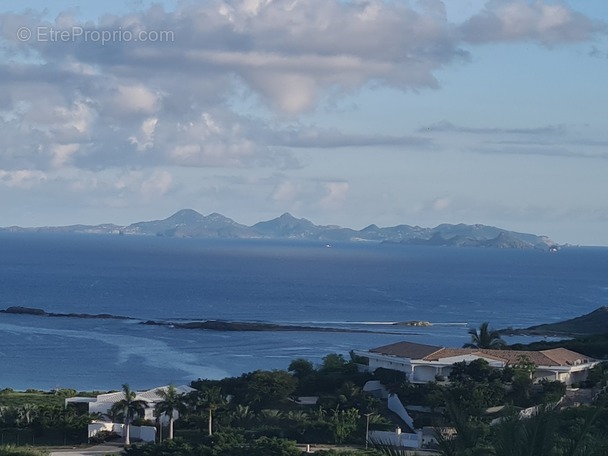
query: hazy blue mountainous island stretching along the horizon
[{"left": 0, "top": 209, "right": 559, "bottom": 251}]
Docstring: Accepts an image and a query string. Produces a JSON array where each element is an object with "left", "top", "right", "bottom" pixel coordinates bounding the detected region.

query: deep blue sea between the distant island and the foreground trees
[{"left": 0, "top": 233, "right": 608, "bottom": 390}]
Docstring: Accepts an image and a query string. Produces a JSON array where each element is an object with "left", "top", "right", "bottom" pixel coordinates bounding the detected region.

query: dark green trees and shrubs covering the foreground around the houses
[{"left": 0, "top": 334, "right": 608, "bottom": 456}]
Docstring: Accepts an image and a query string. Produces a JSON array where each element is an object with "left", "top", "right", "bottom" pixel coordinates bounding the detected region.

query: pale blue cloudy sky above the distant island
[{"left": 0, "top": 0, "right": 608, "bottom": 246}]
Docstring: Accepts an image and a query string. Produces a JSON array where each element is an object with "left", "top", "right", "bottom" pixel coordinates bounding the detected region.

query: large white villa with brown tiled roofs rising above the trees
[{"left": 355, "top": 341, "right": 599, "bottom": 386}]
